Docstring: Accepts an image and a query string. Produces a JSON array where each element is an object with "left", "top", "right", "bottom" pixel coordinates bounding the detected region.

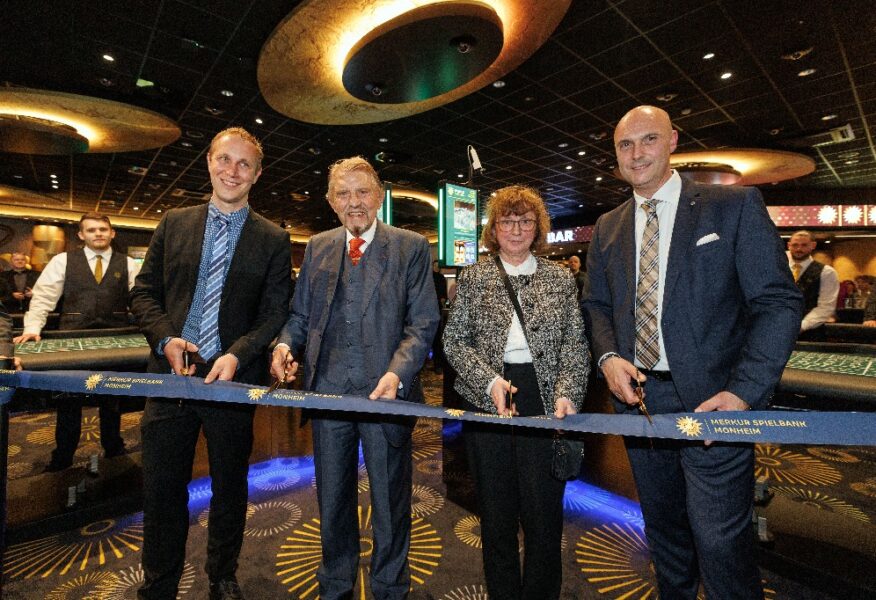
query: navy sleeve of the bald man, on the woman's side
[{"left": 581, "top": 217, "right": 618, "bottom": 363}]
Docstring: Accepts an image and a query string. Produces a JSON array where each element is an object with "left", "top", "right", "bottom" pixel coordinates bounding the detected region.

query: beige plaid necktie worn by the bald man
[{"left": 636, "top": 199, "right": 660, "bottom": 369}]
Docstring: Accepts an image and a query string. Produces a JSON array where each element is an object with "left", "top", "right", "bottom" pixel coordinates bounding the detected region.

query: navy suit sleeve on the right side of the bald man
[{"left": 726, "top": 188, "right": 803, "bottom": 409}]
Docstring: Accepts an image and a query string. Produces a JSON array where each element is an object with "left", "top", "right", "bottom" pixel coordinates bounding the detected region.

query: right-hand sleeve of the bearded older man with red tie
[{"left": 386, "top": 237, "right": 441, "bottom": 395}]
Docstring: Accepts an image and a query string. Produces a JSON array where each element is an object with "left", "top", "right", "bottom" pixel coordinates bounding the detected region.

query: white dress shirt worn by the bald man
[{"left": 633, "top": 169, "right": 681, "bottom": 371}]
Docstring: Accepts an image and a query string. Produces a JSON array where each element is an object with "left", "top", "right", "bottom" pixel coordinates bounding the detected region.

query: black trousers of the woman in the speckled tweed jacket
[{"left": 462, "top": 364, "right": 566, "bottom": 600}]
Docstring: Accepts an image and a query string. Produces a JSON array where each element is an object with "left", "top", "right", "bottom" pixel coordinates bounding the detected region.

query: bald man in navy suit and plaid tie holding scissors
[{"left": 582, "top": 106, "right": 802, "bottom": 600}]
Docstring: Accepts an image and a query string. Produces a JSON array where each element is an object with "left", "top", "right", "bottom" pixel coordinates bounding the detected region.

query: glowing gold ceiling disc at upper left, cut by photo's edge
[{"left": 0, "top": 88, "right": 180, "bottom": 154}]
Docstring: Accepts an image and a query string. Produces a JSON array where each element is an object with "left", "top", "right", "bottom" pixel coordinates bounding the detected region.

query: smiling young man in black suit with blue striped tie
[{"left": 132, "top": 128, "right": 290, "bottom": 600}]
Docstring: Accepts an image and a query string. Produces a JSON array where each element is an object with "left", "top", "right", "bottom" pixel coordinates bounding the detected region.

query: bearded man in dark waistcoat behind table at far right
[{"left": 788, "top": 230, "right": 839, "bottom": 341}]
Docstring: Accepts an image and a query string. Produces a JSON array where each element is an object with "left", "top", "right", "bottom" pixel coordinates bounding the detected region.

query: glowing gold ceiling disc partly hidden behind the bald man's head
[{"left": 669, "top": 148, "right": 815, "bottom": 185}]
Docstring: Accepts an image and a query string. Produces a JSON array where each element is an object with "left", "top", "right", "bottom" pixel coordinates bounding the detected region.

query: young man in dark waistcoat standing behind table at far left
[{"left": 14, "top": 213, "right": 139, "bottom": 471}]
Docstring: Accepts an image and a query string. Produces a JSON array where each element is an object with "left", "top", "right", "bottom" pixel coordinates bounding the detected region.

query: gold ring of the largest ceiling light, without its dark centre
[{"left": 258, "top": 0, "right": 571, "bottom": 125}]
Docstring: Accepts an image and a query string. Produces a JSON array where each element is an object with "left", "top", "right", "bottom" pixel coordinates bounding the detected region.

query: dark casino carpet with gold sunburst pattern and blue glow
[{"left": 3, "top": 372, "right": 876, "bottom": 600}]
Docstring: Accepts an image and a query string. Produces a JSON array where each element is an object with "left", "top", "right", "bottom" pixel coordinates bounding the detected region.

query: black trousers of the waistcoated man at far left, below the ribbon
[{"left": 52, "top": 394, "right": 125, "bottom": 465}]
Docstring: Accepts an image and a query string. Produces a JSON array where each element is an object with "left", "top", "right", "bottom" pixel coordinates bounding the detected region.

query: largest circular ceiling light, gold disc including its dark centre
[{"left": 258, "top": 0, "right": 571, "bottom": 125}]
